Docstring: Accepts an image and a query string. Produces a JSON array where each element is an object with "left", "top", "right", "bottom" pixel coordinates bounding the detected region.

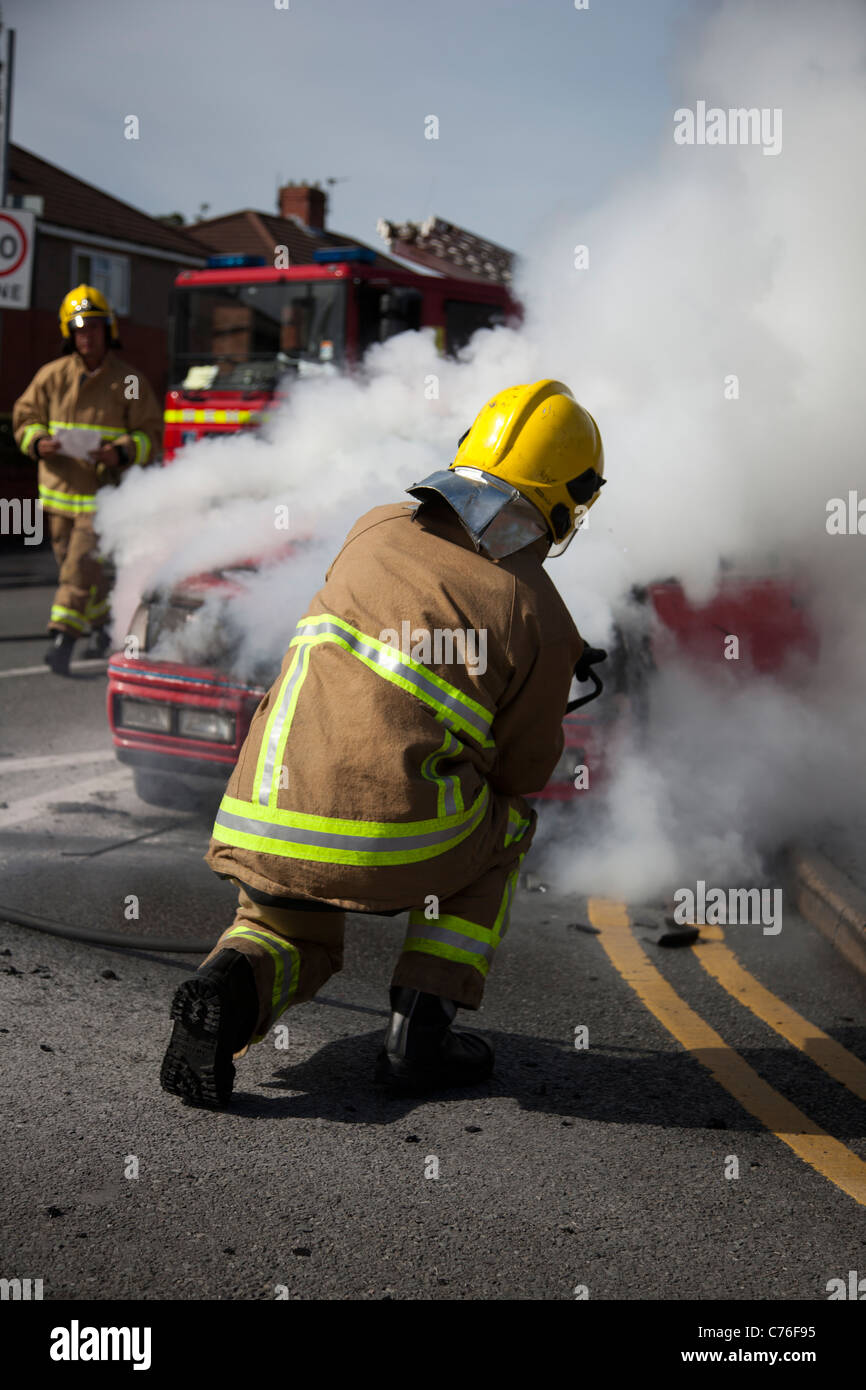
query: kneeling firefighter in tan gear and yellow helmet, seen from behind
[{"left": 161, "top": 381, "right": 603, "bottom": 1108}]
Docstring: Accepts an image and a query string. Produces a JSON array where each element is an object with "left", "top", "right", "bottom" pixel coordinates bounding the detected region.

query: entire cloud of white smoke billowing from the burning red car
[{"left": 99, "top": 0, "right": 866, "bottom": 898}]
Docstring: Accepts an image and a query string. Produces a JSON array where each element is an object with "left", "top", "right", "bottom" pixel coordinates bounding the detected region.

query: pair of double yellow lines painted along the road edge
[{"left": 589, "top": 898, "right": 866, "bottom": 1207}]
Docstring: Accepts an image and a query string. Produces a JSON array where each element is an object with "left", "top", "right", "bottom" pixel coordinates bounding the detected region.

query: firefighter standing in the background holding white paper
[{"left": 13, "top": 285, "right": 161, "bottom": 676}]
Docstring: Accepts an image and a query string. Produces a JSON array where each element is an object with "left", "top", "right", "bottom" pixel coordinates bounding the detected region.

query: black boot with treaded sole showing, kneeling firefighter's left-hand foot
[{"left": 160, "top": 949, "right": 259, "bottom": 1111}]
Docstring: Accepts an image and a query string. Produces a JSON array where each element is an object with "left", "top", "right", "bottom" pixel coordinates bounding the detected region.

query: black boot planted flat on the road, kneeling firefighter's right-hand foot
[{"left": 375, "top": 986, "right": 493, "bottom": 1093}]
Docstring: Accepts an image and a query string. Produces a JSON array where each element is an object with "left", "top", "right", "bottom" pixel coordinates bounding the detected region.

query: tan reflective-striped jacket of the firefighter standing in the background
[{"left": 13, "top": 352, "right": 163, "bottom": 516}]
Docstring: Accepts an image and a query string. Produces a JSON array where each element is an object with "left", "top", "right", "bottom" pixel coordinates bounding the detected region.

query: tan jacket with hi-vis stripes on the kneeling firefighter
[{"left": 206, "top": 502, "right": 582, "bottom": 912}]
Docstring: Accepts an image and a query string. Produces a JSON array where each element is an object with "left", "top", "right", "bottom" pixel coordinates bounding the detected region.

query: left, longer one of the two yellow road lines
[{"left": 588, "top": 898, "right": 866, "bottom": 1205}]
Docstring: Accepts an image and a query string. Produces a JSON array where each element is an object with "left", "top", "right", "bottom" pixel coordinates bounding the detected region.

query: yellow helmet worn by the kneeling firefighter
[{"left": 450, "top": 378, "right": 605, "bottom": 555}]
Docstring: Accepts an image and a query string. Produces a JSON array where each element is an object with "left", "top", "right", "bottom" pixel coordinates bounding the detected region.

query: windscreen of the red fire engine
[{"left": 171, "top": 281, "right": 346, "bottom": 391}]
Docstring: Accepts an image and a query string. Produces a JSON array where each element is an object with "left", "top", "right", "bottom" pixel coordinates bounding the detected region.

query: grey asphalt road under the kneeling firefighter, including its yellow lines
[{"left": 0, "top": 542, "right": 866, "bottom": 1301}]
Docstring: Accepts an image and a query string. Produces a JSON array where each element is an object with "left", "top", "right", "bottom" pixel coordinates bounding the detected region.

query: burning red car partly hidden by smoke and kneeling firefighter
[{"left": 108, "top": 546, "right": 817, "bottom": 805}]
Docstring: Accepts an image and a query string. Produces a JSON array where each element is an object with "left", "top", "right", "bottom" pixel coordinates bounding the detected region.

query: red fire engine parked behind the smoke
[{"left": 164, "top": 246, "right": 520, "bottom": 460}]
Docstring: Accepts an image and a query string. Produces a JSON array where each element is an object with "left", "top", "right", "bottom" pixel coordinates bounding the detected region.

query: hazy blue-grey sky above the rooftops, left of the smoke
[{"left": 1, "top": 0, "right": 697, "bottom": 253}]
